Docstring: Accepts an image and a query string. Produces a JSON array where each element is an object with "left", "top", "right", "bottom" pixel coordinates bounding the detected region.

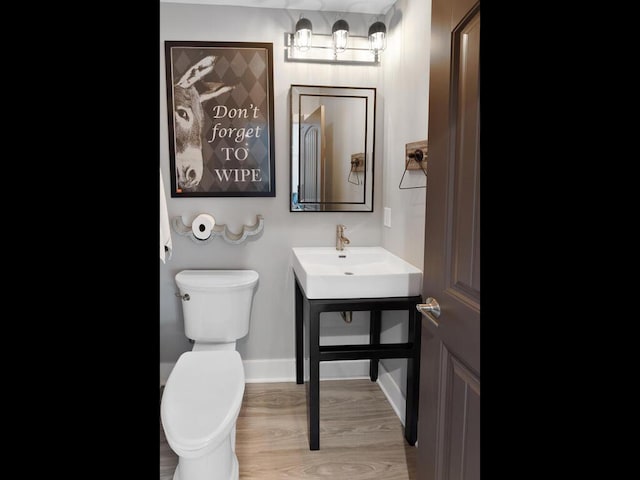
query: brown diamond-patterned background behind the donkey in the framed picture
[{"left": 168, "top": 42, "right": 275, "bottom": 196}]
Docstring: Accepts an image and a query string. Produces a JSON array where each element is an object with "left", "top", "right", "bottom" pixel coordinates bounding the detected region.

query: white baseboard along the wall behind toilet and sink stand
[{"left": 160, "top": 358, "right": 405, "bottom": 425}]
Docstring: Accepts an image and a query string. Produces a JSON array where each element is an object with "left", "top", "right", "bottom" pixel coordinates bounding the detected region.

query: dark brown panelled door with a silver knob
[{"left": 417, "top": 0, "right": 480, "bottom": 480}]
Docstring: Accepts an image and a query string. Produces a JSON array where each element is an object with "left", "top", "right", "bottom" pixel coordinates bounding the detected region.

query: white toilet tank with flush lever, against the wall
[{"left": 175, "top": 270, "right": 258, "bottom": 343}]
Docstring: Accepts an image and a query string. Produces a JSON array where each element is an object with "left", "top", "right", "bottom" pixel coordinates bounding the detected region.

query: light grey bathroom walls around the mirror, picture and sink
[{"left": 159, "top": 0, "right": 430, "bottom": 404}]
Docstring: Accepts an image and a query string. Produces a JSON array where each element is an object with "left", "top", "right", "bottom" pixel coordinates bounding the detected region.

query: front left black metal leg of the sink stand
[{"left": 307, "top": 308, "right": 320, "bottom": 450}]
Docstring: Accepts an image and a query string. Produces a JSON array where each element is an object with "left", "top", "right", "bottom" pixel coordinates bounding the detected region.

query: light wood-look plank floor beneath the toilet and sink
[{"left": 160, "top": 380, "right": 416, "bottom": 480}]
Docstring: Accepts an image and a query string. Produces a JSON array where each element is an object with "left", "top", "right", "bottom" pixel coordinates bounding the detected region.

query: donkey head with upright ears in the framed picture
[{"left": 173, "top": 55, "right": 235, "bottom": 191}]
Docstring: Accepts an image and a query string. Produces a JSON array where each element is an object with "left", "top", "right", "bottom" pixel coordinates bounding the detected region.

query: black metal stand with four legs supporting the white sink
[{"left": 293, "top": 272, "right": 422, "bottom": 450}]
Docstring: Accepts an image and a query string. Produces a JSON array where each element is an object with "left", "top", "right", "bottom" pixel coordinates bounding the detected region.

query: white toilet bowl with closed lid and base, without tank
[{"left": 160, "top": 350, "right": 244, "bottom": 480}]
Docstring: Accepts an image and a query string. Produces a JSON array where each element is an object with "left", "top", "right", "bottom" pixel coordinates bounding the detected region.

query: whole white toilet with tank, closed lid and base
[{"left": 160, "top": 270, "right": 258, "bottom": 480}]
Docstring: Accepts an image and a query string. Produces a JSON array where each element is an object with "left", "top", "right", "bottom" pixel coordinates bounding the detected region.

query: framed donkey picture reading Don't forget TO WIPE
[{"left": 165, "top": 41, "right": 276, "bottom": 197}]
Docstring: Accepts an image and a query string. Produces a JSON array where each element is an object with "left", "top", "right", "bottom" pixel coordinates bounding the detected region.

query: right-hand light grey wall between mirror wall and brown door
[{"left": 381, "top": 0, "right": 431, "bottom": 395}]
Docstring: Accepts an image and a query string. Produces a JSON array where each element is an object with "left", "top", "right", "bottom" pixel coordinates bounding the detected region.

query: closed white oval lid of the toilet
[{"left": 161, "top": 350, "right": 244, "bottom": 450}]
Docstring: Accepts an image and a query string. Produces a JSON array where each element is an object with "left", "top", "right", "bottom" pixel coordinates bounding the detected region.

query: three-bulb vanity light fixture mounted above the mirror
[{"left": 284, "top": 16, "right": 387, "bottom": 65}]
